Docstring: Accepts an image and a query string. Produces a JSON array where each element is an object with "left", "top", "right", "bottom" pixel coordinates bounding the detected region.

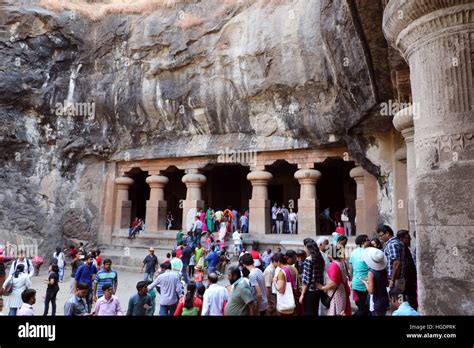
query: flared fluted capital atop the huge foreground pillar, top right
[{"left": 383, "top": 0, "right": 474, "bottom": 59}]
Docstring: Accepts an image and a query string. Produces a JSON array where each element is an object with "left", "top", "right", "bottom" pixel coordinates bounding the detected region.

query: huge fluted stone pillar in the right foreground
[{"left": 383, "top": 0, "right": 474, "bottom": 315}]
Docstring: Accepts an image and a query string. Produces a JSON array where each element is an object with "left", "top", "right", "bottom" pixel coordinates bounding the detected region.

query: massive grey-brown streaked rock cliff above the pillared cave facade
[{"left": 0, "top": 0, "right": 390, "bottom": 253}]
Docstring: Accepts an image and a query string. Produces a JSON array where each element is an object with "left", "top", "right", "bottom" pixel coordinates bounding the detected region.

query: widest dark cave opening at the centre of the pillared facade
[{"left": 202, "top": 163, "right": 252, "bottom": 226}]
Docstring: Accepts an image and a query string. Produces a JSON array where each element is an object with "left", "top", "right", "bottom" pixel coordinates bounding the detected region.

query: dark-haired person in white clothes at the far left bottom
[{"left": 3, "top": 263, "right": 31, "bottom": 316}]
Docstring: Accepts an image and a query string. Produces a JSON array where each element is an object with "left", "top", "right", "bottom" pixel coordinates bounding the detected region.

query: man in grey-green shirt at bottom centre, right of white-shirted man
[{"left": 225, "top": 266, "right": 257, "bottom": 316}]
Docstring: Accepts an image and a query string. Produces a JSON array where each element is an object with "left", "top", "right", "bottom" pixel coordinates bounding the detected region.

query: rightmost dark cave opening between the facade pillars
[{"left": 315, "top": 157, "right": 357, "bottom": 235}]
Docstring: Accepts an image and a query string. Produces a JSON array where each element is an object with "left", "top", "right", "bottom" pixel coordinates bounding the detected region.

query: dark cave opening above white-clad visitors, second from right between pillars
[{"left": 266, "top": 160, "right": 300, "bottom": 233}]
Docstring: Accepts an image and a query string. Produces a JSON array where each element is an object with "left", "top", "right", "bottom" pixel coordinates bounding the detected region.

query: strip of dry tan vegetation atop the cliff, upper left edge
[{"left": 38, "top": 0, "right": 180, "bottom": 20}]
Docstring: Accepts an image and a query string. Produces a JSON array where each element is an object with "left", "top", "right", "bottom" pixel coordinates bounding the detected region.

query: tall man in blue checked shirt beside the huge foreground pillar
[{"left": 377, "top": 225, "right": 405, "bottom": 292}]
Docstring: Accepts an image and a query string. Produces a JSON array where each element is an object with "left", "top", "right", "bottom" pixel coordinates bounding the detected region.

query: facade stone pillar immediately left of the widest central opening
[{"left": 182, "top": 169, "right": 206, "bottom": 231}]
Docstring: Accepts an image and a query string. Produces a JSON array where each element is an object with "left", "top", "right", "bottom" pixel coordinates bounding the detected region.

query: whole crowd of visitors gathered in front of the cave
[{"left": 0, "top": 219, "right": 418, "bottom": 316}]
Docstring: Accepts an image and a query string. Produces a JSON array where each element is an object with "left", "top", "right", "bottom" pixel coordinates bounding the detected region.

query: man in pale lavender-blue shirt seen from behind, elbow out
[{"left": 148, "top": 262, "right": 182, "bottom": 316}]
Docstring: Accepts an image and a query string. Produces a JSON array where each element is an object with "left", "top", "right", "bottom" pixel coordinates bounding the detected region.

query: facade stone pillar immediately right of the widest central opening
[{"left": 247, "top": 170, "right": 273, "bottom": 234}]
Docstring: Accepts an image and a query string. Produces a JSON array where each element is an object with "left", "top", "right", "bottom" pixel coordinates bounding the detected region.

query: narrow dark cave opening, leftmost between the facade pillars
[{"left": 127, "top": 168, "right": 150, "bottom": 224}]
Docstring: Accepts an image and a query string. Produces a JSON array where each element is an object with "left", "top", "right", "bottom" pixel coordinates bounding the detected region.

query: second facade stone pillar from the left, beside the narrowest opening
[{"left": 145, "top": 175, "right": 169, "bottom": 232}]
